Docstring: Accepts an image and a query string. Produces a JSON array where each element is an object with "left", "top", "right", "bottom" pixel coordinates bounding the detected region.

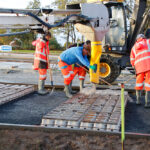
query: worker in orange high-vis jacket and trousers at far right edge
[{"left": 130, "top": 34, "right": 150, "bottom": 108}]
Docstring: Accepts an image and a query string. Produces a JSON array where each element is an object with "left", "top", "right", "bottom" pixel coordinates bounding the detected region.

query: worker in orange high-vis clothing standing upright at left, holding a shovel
[{"left": 32, "top": 32, "right": 51, "bottom": 95}]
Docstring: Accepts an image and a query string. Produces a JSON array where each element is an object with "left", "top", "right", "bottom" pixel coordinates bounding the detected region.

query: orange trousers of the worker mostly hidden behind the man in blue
[{"left": 73, "top": 67, "right": 86, "bottom": 80}]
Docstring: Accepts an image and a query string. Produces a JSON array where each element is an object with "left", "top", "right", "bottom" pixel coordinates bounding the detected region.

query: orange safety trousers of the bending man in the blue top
[{"left": 58, "top": 58, "right": 74, "bottom": 85}]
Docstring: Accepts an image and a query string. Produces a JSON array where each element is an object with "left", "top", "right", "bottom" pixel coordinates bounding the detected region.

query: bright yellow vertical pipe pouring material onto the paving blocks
[{"left": 90, "top": 41, "right": 102, "bottom": 84}]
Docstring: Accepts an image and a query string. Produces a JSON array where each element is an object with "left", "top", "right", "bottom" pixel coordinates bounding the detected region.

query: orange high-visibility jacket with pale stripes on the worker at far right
[{"left": 130, "top": 38, "right": 150, "bottom": 74}]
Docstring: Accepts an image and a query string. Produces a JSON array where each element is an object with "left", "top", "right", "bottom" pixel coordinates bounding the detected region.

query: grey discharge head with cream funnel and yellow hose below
[{"left": 75, "top": 3, "right": 109, "bottom": 84}]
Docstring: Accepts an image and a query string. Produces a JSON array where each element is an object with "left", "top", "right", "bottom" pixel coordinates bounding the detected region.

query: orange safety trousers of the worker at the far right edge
[{"left": 135, "top": 71, "right": 150, "bottom": 91}]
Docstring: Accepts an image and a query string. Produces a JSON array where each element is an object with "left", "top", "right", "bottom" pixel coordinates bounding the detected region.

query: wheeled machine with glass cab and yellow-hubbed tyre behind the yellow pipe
[{"left": 85, "top": 0, "right": 150, "bottom": 83}]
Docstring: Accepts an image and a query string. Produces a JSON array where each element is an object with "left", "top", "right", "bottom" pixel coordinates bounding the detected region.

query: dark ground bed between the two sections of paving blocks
[{"left": 0, "top": 90, "right": 67, "bottom": 125}]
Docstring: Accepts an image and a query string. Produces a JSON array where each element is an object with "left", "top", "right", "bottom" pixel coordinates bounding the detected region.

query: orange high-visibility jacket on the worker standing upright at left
[{"left": 34, "top": 39, "right": 49, "bottom": 70}]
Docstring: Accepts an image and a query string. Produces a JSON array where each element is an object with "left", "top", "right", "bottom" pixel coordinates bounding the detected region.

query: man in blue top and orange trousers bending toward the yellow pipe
[{"left": 58, "top": 43, "right": 96, "bottom": 98}]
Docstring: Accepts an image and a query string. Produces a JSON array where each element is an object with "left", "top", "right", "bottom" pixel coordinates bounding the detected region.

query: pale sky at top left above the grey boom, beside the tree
[{"left": 0, "top": 0, "right": 52, "bottom": 8}]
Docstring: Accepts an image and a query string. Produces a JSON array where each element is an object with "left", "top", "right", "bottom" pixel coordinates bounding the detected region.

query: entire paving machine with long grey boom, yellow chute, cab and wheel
[{"left": 0, "top": 0, "right": 150, "bottom": 83}]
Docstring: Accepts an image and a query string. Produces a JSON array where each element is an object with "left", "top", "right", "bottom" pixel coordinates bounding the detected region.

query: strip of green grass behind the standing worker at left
[{"left": 1, "top": 50, "right": 62, "bottom": 55}]
